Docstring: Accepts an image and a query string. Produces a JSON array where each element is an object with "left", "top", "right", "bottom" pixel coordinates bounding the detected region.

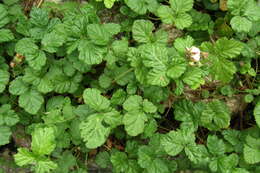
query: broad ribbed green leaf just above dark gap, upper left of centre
[{"left": 78, "top": 40, "right": 106, "bottom": 65}]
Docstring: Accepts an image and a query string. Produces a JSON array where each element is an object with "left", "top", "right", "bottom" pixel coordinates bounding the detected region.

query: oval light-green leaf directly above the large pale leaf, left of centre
[{"left": 83, "top": 88, "right": 110, "bottom": 111}]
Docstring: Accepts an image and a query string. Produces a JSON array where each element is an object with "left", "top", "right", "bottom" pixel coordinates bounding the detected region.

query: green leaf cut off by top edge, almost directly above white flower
[{"left": 170, "top": 0, "right": 193, "bottom": 13}]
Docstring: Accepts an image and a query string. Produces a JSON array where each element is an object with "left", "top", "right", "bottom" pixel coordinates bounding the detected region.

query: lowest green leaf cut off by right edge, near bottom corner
[{"left": 243, "top": 136, "right": 260, "bottom": 164}]
